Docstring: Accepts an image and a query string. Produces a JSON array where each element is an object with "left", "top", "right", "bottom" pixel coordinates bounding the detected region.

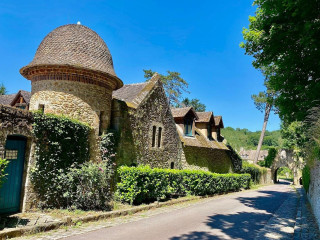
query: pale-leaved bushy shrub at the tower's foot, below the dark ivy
[{"left": 57, "top": 162, "right": 111, "bottom": 210}]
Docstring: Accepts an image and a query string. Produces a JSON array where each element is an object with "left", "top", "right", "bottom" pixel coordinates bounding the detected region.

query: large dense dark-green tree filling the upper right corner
[{"left": 240, "top": 0, "right": 320, "bottom": 123}]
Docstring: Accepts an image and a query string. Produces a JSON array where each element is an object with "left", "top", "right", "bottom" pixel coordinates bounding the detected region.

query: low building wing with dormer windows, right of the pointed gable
[{"left": 172, "top": 107, "right": 234, "bottom": 173}]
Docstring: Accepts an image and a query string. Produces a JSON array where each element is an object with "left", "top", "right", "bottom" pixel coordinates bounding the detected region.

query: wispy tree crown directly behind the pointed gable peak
[{"left": 143, "top": 69, "right": 188, "bottom": 106}]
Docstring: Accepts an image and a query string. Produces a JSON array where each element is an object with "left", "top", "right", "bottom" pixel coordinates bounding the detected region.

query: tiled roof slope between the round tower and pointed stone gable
[{"left": 112, "top": 73, "right": 160, "bottom": 108}]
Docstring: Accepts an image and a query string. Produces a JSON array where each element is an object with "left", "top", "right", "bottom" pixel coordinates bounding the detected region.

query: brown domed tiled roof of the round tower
[{"left": 20, "top": 24, "right": 122, "bottom": 88}]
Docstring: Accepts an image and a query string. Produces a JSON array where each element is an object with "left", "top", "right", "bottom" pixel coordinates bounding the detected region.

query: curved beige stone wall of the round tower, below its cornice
[{"left": 30, "top": 80, "right": 112, "bottom": 135}]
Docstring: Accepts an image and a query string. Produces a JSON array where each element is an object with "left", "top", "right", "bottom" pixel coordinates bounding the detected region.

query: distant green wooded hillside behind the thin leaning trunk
[{"left": 221, "top": 127, "right": 282, "bottom": 150}]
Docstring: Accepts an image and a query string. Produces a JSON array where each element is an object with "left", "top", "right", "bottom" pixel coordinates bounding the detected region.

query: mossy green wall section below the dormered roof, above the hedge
[{"left": 183, "top": 146, "right": 233, "bottom": 173}]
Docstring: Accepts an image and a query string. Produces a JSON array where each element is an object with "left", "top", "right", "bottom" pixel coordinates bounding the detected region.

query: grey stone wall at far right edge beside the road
[{"left": 308, "top": 160, "right": 320, "bottom": 226}]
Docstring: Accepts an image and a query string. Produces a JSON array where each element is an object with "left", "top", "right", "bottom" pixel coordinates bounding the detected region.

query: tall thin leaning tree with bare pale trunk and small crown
[{"left": 251, "top": 91, "right": 275, "bottom": 163}]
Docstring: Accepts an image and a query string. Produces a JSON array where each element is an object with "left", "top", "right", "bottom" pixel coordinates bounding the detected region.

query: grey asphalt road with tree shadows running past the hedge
[{"left": 64, "top": 184, "right": 292, "bottom": 240}]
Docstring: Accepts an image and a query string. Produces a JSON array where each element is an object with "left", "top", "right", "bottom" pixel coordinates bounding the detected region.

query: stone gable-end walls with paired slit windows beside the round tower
[{"left": 112, "top": 82, "right": 183, "bottom": 169}]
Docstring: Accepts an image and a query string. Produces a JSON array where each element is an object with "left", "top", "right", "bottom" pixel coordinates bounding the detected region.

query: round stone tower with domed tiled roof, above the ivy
[{"left": 20, "top": 24, "right": 123, "bottom": 134}]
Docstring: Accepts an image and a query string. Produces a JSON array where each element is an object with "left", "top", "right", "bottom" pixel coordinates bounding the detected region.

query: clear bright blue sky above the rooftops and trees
[{"left": 0, "top": 0, "right": 280, "bottom": 131}]
